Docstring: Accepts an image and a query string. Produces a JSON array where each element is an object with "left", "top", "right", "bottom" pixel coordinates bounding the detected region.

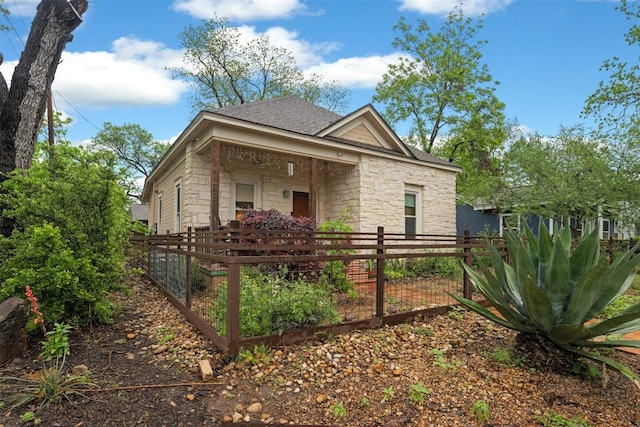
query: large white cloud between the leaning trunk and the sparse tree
[{"left": 53, "top": 37, "right": 188, "bottom": 108}]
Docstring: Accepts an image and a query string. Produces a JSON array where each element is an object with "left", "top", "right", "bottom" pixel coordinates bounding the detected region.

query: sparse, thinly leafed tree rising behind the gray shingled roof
[{"left": 173, "top": 17, "right": 349, "bottom": 112}]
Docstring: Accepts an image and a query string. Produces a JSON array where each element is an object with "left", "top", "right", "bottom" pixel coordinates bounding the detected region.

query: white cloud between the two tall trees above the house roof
[{"left": 304, "top": 53, "right": 400, "bottom": 89}]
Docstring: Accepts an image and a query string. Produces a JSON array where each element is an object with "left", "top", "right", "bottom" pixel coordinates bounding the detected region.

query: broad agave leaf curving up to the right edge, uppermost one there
[{"left": 586, "top": 251, "right": 640, "bottom": 319}]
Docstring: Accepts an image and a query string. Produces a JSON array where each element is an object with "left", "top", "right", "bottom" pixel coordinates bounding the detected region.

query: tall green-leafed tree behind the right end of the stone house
[{"left": 373, "top": 8, "right": 504, "bottom": 160}]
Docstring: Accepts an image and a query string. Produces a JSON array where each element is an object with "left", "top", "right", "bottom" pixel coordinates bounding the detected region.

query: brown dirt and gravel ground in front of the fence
[{"left": 0, "top": 277, "right": 640, "bottom": 427}]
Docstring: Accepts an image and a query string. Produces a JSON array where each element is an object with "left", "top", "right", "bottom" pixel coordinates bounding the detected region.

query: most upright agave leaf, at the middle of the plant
[{"left": 543, "top": 232, "right": 571, "bottom": 324}]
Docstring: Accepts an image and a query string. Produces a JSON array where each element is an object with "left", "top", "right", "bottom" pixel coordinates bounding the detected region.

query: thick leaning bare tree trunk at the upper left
[{"left": 0, "top": 0, "right": 88, "bottom": 236}]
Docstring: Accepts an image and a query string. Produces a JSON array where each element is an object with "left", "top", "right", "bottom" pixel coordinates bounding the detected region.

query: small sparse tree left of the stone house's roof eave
[{"left": 91, "top": 122, "right": 171, "bottom": 199}]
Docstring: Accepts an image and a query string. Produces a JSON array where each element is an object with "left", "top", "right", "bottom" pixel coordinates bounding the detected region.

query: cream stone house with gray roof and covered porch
[{"left": 142, "top": 96, "right": 460, "bottom": 235}]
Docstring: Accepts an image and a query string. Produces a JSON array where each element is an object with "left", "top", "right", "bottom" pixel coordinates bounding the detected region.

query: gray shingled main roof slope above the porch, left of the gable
[{"left": 209, "top": 96, "right": 342, "bottom": 135}]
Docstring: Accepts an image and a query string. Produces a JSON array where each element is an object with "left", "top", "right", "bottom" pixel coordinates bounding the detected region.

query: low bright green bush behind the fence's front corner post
[{"left": 211, "top": 271, "right": 340, "bottom": 337}]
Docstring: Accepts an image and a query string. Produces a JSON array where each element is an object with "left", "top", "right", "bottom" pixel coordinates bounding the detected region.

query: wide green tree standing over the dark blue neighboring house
[{"left": 492, "top": 127, "right": 640, "bottom": 236}]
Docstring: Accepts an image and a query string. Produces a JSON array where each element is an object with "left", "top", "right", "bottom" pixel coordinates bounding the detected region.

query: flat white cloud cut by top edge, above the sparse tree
[{"left": 173, "top": 0, "right": 306, "bottom": 21}]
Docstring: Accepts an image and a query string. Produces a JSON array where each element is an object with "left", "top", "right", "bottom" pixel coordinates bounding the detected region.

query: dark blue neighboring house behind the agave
[{"left": 456, "top": 200, "right": 635, "bottom": 240}]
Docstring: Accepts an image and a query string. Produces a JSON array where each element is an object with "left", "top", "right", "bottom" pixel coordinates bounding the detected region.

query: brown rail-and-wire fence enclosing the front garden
[{"left": 127, "top": 227, "right": 506, "bottom": 354}]
